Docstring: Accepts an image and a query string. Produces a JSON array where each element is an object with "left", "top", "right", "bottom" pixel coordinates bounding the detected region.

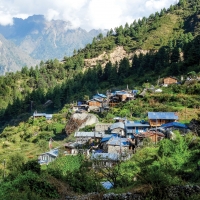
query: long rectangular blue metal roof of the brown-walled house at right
[{"left": 148, "top": 112, "right": 178, "bottom": 120}]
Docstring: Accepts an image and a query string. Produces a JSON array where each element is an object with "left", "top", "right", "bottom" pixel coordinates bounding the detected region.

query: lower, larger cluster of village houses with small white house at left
[{"left": 39, "top": 112, "right": 188, "bottom": 167}]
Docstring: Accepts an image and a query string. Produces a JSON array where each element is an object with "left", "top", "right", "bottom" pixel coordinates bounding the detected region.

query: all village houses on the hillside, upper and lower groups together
[{"left": 37, "top": 77, "right": 192, "bottom": 166}]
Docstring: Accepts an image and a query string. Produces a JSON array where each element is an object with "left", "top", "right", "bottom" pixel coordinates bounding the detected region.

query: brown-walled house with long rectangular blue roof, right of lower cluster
[{"left": 148, "top": 112, "right": 178, "bottom": 127}]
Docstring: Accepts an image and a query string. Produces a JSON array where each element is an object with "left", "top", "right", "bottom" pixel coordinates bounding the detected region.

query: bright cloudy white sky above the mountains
[{"left": 0, "top": 0, "right": 177, "bottom": 30}]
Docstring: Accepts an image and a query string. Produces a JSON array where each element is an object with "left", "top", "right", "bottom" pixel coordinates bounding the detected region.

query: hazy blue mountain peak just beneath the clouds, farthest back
[{"left": 0, "top": 15, "right": 106, "bottom": 61}]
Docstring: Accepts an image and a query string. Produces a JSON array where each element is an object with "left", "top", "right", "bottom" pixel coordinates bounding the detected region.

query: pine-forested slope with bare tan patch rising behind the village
[{"left": 0, "top": 1, "right": 200, "bottom": 126}]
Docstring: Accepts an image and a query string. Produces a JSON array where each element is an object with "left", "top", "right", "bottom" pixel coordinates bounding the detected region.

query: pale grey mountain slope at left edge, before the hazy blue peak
[{"left": 0, "top": 34, "right": 39, "bottom": 75}]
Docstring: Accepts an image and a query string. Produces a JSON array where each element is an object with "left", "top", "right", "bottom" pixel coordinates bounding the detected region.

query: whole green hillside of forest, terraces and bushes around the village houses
[{"left": 0, "top": 0, "right": 200, "bottom": 200}]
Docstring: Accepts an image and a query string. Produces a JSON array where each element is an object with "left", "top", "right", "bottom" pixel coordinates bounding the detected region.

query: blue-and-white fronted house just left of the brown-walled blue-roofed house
[{"left": 124, "top": 121, "right": 150, "bottom": 138}]
